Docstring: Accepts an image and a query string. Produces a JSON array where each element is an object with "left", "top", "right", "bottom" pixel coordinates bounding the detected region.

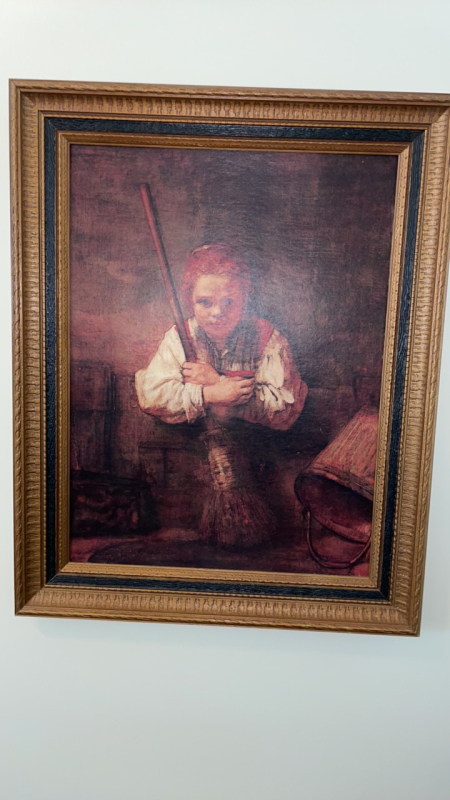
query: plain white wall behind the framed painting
[{"left": 0, "top": 0, "right": 450, "bottom": 800}]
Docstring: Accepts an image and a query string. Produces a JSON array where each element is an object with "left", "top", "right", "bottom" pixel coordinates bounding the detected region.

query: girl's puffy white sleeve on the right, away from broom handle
[{"left": 237, "top": 331, "right": 308, "bottom": 431}]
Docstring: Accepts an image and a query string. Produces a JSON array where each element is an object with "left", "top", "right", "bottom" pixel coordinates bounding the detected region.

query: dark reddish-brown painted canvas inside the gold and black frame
[{"left": 70, "top": 142, "right": 398, "bottom": 578}]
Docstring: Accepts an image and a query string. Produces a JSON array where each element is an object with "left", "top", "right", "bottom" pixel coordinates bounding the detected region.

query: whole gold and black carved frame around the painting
[{"left": 11, "top": 81, "right": 450, "bottom": 634}]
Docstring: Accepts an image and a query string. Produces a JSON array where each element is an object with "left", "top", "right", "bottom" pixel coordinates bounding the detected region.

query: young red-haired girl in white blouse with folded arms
[{"left": 136, "top": 244, "right": 307, "bottom": 546}]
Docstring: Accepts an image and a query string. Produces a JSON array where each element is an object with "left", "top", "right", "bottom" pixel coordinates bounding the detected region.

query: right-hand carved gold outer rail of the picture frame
[{"left": 393, "top": 110, "right": 450, "bottom": 635}]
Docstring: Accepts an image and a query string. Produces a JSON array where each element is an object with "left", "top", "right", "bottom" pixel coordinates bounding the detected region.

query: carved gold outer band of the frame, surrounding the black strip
[{"left": 11, "top": 81, "right": 450, "bottom": 635}]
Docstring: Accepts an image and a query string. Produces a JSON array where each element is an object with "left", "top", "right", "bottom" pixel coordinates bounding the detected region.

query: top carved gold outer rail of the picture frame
[{"left": 11, "top": 86, "right": 450, "bottom": 128}]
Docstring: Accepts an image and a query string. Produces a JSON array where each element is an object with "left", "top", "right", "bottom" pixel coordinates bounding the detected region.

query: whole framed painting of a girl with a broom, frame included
[{"left": 11, "top": 81, "right": 450, "bottom": 634}]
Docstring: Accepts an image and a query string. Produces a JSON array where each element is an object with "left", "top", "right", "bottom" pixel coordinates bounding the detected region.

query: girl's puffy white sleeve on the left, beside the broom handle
[{"left": 135, "top": 328, "right": 204, "bottom": 424}]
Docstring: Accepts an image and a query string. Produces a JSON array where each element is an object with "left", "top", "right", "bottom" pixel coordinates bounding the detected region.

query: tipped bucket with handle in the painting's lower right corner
[{"left": 295, "top": 406, "right": 378, "bottom": 569}]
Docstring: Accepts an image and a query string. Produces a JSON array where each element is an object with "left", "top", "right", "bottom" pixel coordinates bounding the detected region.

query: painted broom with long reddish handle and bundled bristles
[{"left": 139, "top": 183, "right": 276, "bottom": 548}]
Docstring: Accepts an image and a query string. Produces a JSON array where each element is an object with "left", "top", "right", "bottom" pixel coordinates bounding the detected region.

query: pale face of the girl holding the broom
[{"left": 192, "top": 275, "right": 246, "bottom": 347}]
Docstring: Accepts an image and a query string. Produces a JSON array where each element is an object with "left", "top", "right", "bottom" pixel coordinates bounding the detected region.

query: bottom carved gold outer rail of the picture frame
[{"left": 16, "top": 586, "right": 415, "bottom": 635}]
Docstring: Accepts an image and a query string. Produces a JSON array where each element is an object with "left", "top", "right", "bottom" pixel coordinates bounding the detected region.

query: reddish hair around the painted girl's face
[{"left": 181, "top": 244, "right": 251, "bottom": 314}]
